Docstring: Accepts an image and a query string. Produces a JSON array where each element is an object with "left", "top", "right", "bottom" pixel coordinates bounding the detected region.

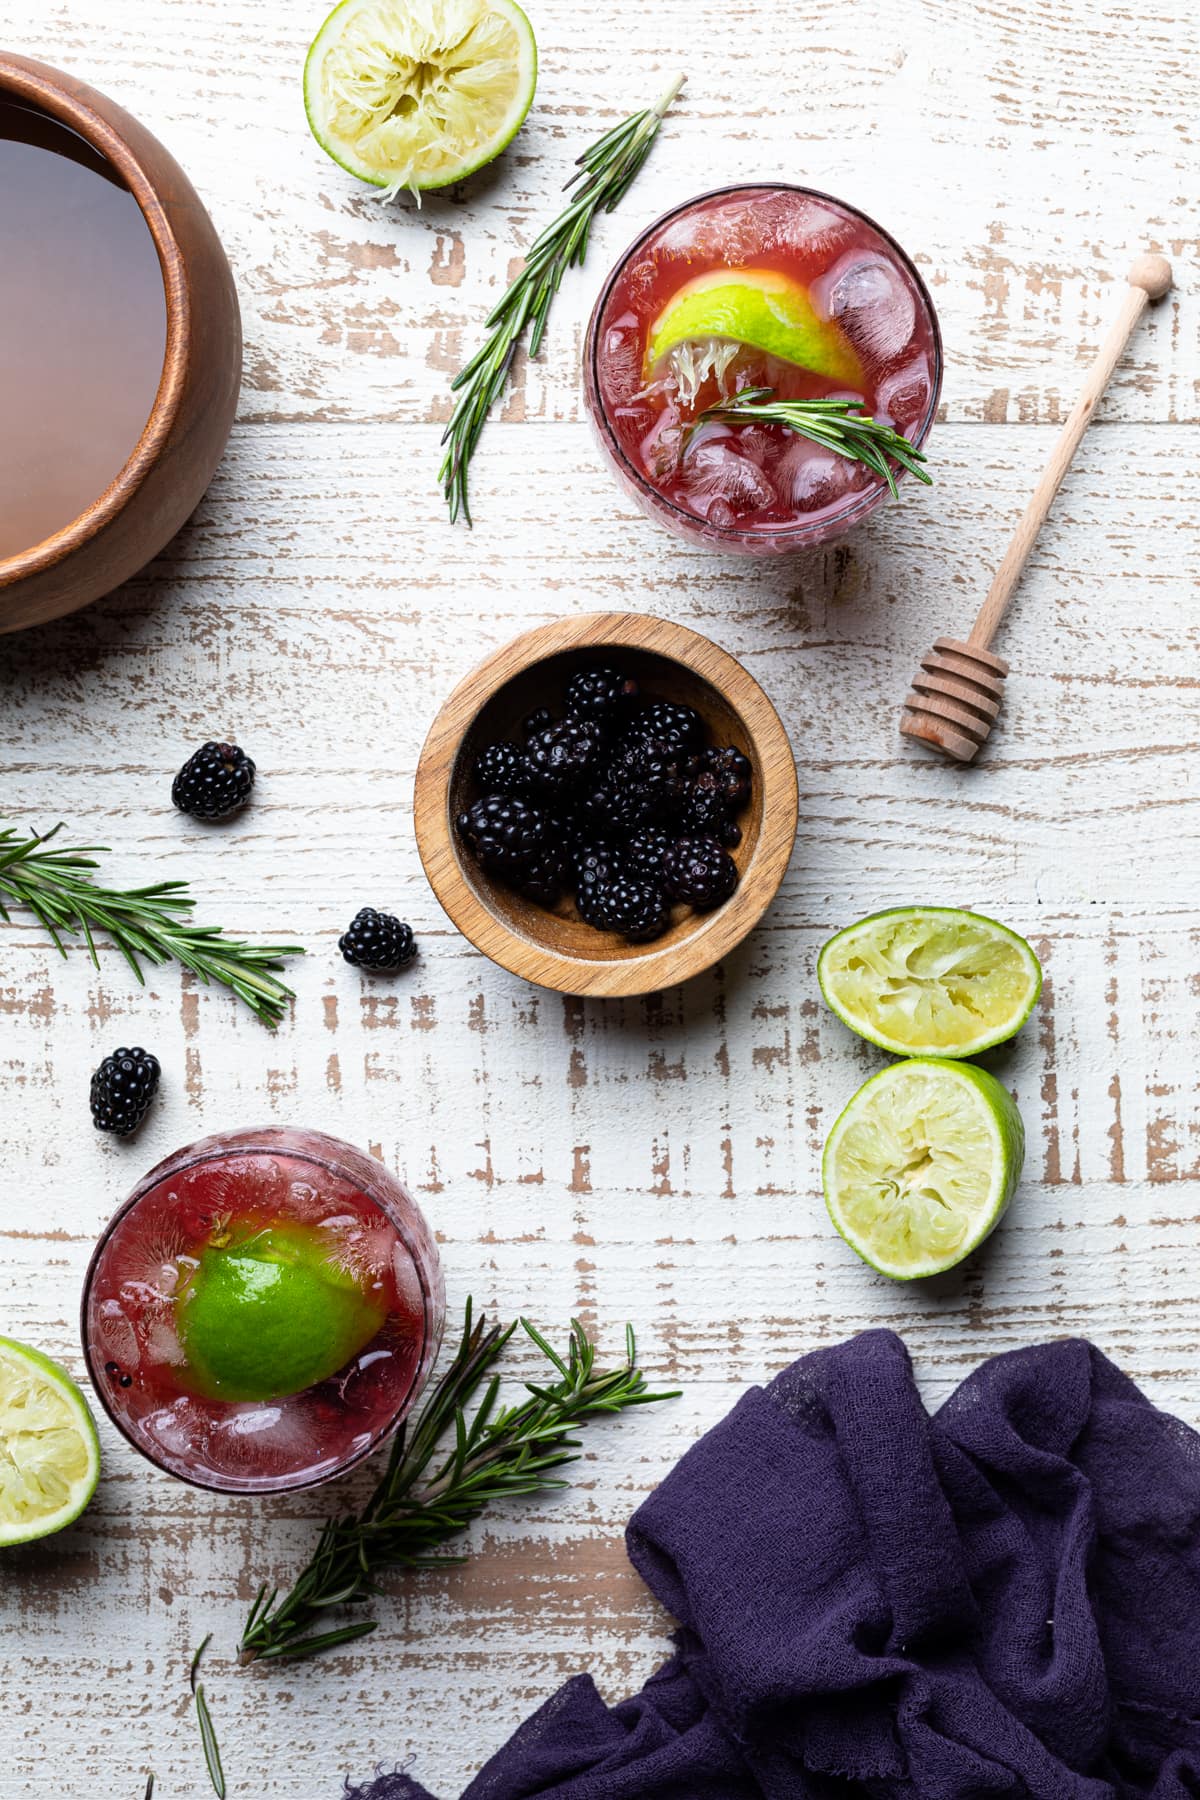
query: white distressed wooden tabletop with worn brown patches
[{"left": 0, "top": 0, "right": 1200, "bottom": 1800}]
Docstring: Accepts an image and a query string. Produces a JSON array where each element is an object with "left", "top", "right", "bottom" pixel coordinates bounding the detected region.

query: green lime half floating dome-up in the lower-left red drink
[{"left": 176, "top": 1226, "right": 385, "bottom": 1400}]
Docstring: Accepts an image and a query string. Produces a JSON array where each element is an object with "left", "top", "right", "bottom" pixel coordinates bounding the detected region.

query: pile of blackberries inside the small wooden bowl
[{"left": 455, "top": 659, "right": 754, "bottom": 943}]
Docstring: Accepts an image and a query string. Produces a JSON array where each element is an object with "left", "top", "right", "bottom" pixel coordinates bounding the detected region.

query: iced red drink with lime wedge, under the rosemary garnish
[{"left": 585, "top": 185, "right": 941, "bottom": 554}]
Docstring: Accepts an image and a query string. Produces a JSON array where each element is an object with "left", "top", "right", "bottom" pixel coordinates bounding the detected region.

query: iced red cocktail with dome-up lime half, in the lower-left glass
[{"left": 83, "top": 1129, "right": 444, "bottom": 1492}]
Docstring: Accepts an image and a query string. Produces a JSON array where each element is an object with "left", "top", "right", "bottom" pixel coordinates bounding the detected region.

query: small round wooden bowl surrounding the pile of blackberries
[{"left": 414, "top": 612, "right": 799, "bottom": 995}]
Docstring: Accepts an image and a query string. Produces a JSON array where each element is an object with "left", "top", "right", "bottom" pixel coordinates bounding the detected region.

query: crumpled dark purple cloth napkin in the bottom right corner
[{"left": 349, "top": 1332, "right": 1200, "bottom": 1800}]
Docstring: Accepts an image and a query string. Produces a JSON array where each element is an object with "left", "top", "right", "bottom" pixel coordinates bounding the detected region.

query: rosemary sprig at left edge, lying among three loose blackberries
[{"left": 0, "top": 824, "right": 304, "bottom": 1026}]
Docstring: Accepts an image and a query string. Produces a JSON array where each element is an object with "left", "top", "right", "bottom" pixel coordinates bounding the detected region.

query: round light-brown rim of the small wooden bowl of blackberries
[{"left": 412, "top": 612, "right": 799, "bottom": 997}]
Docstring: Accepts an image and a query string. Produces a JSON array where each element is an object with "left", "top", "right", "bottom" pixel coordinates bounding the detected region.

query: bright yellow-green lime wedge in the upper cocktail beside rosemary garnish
[{"left": 646, "top": 268, "right": 864, "bottom": 391}]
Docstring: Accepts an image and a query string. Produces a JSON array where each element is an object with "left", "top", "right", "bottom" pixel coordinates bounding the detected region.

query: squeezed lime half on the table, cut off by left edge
[{"left": 0, "top": 1337, "right": 101, "bottom": 1546}]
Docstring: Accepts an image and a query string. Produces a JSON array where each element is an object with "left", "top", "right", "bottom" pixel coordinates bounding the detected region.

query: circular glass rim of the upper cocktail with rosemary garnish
[{"left": 583, "top": 180, "right": 946, "bottom": 551}]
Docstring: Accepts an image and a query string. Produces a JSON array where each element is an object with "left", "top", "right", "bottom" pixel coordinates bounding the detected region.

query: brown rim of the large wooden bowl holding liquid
[{"left": 0, "top": 50, "right": 191, "bottom": 592}]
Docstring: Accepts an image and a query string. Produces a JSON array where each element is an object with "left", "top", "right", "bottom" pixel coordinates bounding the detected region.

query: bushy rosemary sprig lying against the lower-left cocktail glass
[{"left": 241, "top": 1300, "right": 675, "bottom": 1661}]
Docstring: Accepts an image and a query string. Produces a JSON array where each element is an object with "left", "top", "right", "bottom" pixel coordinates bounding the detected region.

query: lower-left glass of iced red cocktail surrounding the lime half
[{"left": 83, "top": 1127, "right": 444, "bottom": 1494}]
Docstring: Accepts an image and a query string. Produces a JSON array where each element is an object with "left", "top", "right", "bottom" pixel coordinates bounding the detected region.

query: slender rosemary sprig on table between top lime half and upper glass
[{"left": 437, "top": 76, "right": 685, "bottom": 526}]
